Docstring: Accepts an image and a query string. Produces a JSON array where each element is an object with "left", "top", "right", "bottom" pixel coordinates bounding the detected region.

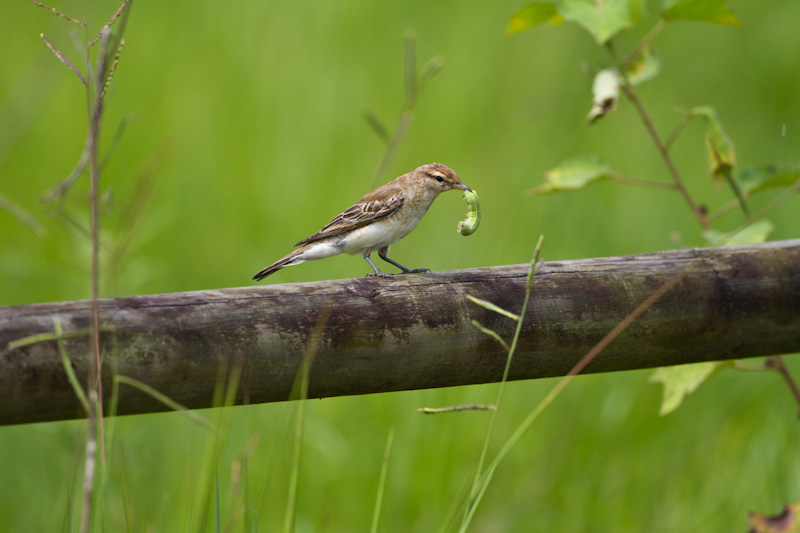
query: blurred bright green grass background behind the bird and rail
[{"left": 0, "top": 0, "right": 800, "bottom": 532}]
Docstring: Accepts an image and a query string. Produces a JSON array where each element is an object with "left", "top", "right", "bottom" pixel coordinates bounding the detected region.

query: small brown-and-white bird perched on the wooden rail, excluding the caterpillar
[{"left": 253, "top": 163, "right": 472, "bottom": 281}]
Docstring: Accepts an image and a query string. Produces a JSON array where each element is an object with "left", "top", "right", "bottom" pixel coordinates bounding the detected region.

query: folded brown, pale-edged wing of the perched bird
[{"left": 295, "top": 187, "right": 405, "bottom": 246}]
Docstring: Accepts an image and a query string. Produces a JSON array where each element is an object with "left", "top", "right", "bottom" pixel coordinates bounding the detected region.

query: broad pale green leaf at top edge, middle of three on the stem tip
[{"left": 558, "top": 0, "right": 633, "bottom": 44}]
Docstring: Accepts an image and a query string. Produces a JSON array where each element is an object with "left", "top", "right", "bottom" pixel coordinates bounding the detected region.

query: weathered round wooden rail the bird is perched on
[{"left": 0, "top": 240, "right": 800, "bottom": 424}]
